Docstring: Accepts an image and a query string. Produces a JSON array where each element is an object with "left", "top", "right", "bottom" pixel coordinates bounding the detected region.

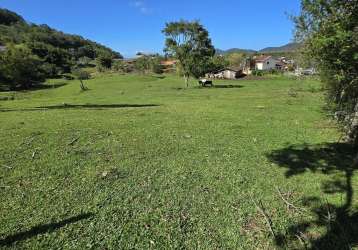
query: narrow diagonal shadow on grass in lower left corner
[{"left": 0, "top": 213, "right": 94, "bottom": 246}]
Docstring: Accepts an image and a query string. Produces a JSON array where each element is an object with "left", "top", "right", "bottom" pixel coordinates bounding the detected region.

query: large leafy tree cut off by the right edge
[{"left": 294, "top": 0, "right": 358, "bottom": 146}]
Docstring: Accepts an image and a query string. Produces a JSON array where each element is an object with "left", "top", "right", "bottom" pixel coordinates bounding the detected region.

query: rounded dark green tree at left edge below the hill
[{"left": 0, "top": 45, "right": 44, "bottom": 89}]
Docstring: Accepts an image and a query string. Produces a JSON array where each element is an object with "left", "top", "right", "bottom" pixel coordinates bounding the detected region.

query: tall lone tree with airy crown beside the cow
[{"left": 163, "top": 20, "right": 215, "bottom": 87}]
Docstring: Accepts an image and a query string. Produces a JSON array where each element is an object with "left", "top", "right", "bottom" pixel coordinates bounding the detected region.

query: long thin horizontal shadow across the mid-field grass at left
[{"left": 0, "top": 104, "right": 160, "bottom": 112}]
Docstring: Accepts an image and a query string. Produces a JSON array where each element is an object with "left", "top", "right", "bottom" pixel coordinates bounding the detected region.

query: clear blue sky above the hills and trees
[{"left": 0, "top": 0, "right": 300, "bottom": 57}]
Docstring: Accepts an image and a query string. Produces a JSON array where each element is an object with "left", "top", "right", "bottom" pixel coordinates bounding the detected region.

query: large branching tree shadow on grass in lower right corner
[{"left": 268, "top": 143, "right": 358, "bottom": 249}]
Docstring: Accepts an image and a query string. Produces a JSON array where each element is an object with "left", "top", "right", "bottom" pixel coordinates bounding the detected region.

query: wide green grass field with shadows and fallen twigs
[{"left": 0, "top": 75, "right": 358, "bottom": 249}]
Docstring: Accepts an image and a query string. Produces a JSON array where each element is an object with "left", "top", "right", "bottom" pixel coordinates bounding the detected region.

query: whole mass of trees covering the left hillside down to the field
[{"left": 0, "top": 9, "right": 122, "bottom": 88}]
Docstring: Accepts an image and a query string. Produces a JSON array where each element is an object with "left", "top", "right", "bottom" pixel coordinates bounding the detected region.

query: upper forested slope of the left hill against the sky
[{"left": 0, "top": 8, "right": 122, "bottom": 70}]
